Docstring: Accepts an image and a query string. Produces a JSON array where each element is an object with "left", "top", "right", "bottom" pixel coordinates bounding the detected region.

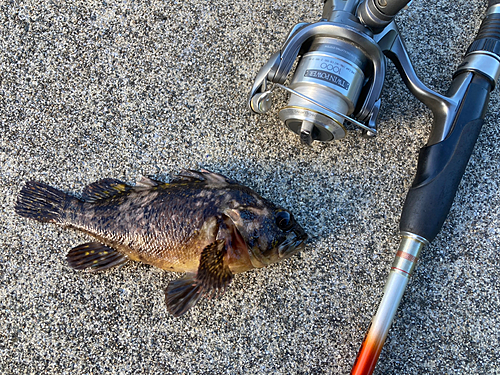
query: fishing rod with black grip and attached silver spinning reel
[{"left": 247, "top": 0, "right": 500, "bottom": 375}]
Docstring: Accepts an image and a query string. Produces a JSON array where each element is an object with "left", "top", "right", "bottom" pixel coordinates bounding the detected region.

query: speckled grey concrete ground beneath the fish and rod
[{"left": 0, "top": 0, "right": 500, "bottom": 374}]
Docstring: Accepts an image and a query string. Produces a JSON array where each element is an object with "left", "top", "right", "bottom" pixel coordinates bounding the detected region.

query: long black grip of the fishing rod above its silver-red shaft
[{"left": 400, "top": 73, "right": 492, "bottom": 242}]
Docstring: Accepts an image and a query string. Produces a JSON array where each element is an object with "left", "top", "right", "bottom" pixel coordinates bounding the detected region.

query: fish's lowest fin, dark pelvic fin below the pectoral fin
[{"left": 165, "top": 274, "right": 203, "bottom": 317}]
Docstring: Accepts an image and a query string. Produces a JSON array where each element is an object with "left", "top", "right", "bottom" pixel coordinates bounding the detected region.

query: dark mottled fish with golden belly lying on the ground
[{"left": 14, "top": 169, "right": 308, "bottom": 317}]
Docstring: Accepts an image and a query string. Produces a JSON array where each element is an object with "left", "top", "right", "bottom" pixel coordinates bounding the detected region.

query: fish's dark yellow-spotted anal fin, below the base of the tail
[{"left": 66, "top": 242, "right": 128, "bottom": 271}]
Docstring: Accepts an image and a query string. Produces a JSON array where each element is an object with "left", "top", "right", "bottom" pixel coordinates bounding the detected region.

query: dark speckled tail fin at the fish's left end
[{"left": 14, "top": 181, "right": 72, "bottom": 223}]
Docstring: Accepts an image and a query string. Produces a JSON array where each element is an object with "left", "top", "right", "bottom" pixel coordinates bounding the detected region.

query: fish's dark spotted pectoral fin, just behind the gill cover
[{"left": 196, "top": 240, "right": 233, "bottom": 295}]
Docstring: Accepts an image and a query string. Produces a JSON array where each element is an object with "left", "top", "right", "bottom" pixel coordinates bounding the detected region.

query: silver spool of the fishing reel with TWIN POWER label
[{"left": 279, "top": 37, "right": 368, "bottom": 145}]
